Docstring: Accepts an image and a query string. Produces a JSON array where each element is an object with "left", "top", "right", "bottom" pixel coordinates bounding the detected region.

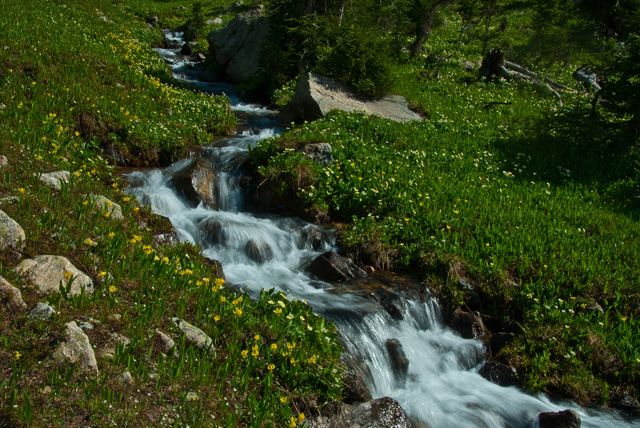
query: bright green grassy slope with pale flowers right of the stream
[{"left": 254, "top": 7, "right": 640, "bottom": 403}]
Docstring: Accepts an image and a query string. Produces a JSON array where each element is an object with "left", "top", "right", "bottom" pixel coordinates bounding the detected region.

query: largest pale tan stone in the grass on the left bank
[{"left": 16, "top": 255, "right": 94, "bottom": 296}]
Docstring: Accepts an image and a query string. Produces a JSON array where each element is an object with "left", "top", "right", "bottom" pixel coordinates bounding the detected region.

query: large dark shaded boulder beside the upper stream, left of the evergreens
[{"left": 207, "top": 10, "right": 269, "bottom": 83}]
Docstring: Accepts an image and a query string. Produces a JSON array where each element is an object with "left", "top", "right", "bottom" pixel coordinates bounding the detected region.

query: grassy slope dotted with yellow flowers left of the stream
[{"left": 0, "top": 0, "right": 341, "bottom": 427}]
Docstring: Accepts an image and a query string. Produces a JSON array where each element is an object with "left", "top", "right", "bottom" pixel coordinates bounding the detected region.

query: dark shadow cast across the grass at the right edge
[{"left": 494, "top": 108, "right": 640, "bottom": 219}]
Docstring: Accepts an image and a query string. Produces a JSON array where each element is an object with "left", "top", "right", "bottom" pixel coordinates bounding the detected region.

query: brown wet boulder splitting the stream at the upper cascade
[{"left": 170, "top": 158, "right": 217, "bottom": 209}]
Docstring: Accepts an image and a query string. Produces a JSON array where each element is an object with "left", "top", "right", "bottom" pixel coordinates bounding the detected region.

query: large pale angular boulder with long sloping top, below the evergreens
[{"left": 281, "top": 73, "right": 422, "bottom": 124}]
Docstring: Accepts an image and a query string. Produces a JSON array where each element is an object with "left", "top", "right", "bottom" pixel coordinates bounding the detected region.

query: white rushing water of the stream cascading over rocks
[{"left": 122, "top": 33, "right": 637, "bottom": 428}]
